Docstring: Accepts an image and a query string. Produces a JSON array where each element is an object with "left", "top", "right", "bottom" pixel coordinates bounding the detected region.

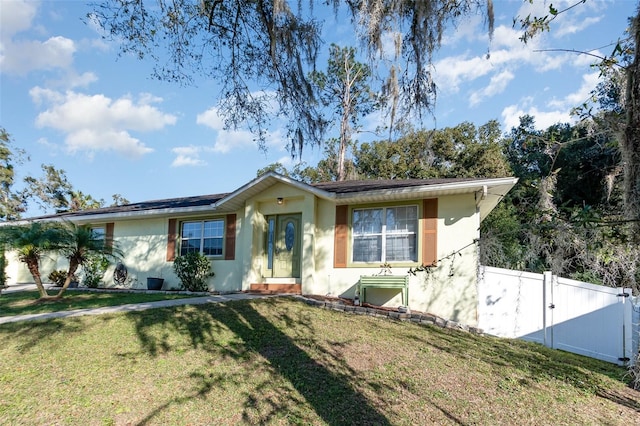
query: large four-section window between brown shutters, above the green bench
[{"left": 352, "top": 206, "right": 418, "bottom": 262}]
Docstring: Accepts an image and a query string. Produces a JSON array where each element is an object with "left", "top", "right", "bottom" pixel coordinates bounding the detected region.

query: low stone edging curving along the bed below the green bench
[{"left": 292, "top": 295, "right": 484, "bottom": 335}]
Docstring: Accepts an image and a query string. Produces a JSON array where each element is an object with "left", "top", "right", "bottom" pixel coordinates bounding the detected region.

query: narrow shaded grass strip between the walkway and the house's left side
[{"left": 0, "top": 289, "right": 190, "bottom": 317}]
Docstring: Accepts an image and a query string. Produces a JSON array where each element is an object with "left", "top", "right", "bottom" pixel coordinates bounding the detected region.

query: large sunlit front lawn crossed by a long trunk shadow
[{"left": 0, "top": 296, "right": 640, "bottom": 425}]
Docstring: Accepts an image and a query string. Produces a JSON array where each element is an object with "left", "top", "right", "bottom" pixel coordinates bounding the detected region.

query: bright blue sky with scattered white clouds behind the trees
[{"left": 0, "top": 0, "right": 637, "bottom": 216}]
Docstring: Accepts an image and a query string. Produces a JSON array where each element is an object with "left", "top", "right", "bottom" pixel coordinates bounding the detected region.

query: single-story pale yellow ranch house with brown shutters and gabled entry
[{"left": 7, "top": 172, "right": 517, "bottom": 326}]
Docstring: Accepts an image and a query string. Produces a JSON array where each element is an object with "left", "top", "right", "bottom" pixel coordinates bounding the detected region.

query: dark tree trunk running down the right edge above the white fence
[{"left": 621, "top": 9, "right": 640, "bottom": 244}]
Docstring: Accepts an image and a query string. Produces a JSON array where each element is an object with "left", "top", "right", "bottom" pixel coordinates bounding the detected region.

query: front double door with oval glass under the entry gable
[{"left": 265, "top": 213, "right": 302, "bottom": 278}]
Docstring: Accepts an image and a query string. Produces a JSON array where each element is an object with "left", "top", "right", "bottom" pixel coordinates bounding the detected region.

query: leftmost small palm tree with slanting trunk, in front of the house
[{"left": 0, "top": 222, "right": 61, "bottom": 298}]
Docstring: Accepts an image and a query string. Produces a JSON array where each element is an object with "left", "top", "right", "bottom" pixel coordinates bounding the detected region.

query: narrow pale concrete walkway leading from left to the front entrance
[{"left": 0, "top": 290, "right": 273, "bottom": 324}]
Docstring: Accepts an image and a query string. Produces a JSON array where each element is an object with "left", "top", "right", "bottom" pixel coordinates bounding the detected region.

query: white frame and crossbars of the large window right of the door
[{"left": 350, "top": 204, "right": 420, "bottom": 265}]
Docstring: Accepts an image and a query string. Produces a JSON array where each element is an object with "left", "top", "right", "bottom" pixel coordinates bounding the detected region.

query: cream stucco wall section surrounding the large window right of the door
[{"left": 303, "top": 194, "right": 480, "bottom": 325}]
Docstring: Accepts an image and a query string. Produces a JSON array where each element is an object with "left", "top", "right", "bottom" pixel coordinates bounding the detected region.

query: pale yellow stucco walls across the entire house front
[{"left": 7, "top": 183, "right": 479, "bottom": 325}]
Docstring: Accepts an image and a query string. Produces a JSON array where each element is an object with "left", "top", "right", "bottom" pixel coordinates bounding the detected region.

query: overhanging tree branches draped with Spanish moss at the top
[{"left": 88, "top": 0, "right": 493, "bottom": 154}]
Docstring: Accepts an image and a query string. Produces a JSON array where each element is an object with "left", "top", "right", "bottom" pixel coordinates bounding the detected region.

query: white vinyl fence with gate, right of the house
[{"left": 478, "top": 266, "right": 638, "bottom": 365}]
